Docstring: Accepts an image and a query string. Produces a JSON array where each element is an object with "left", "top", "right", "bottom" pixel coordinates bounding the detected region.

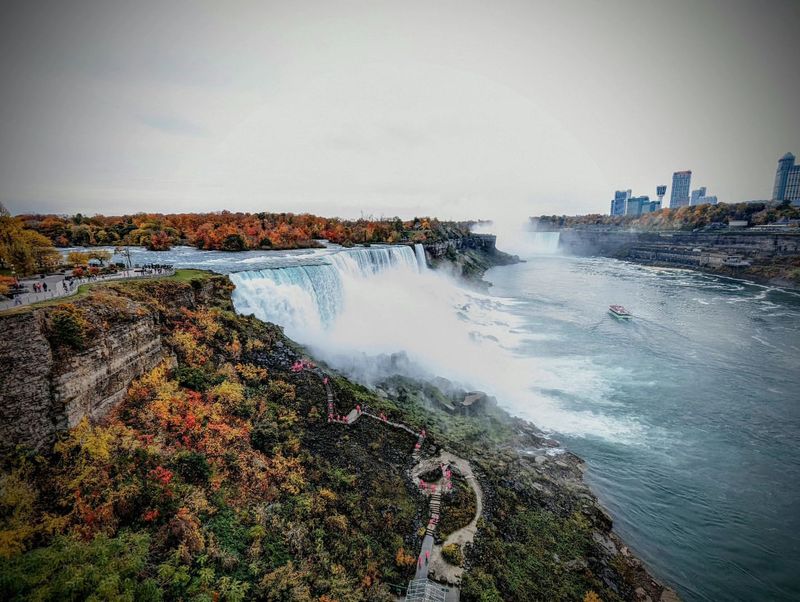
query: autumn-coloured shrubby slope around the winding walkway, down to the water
[{"left": 0, "top": 276, "right": 672, "bottom": 602}]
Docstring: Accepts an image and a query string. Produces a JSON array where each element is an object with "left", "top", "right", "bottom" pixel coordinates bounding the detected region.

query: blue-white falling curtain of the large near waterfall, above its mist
[{"left": 230, "top": 246, "right": 419, "bottom": 340}]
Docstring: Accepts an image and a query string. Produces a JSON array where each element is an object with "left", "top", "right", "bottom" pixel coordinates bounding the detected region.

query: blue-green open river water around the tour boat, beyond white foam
[{"left": 486, "top": 256, "right": 800, "bottom": 601}]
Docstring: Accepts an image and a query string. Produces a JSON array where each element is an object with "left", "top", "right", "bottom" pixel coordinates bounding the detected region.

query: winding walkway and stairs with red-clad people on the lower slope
[{"left": 316, "top": 363, "right": 483, "bottom": 602}]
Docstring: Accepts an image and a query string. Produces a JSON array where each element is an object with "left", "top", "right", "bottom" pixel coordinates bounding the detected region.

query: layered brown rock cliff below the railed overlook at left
[{"left": 0, "top": 277, "right": 229, "bottom": 450}]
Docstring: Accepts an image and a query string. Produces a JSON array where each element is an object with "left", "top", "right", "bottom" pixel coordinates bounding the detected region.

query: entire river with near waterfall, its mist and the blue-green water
[{"left": 104, "top": 241, "right": 800, "bottom": 601}]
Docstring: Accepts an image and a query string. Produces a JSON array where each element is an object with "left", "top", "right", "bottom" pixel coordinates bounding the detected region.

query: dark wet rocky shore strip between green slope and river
[{"left": 377, "top": 377, "right": 680, "bottom": 602}]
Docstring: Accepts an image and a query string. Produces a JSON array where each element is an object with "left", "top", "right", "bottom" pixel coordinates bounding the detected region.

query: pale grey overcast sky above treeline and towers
[{"left": 0, "top": 0, "right": 800, "bottom": 218}]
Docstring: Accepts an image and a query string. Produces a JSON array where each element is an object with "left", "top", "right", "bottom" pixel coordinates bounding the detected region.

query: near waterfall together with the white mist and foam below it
[{"left": 230, "top": 241, "right": 631, "bottom": 438}]
